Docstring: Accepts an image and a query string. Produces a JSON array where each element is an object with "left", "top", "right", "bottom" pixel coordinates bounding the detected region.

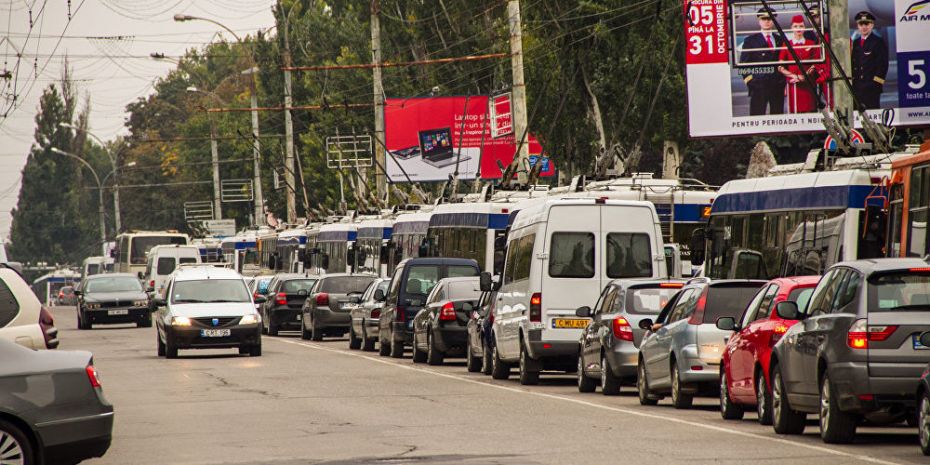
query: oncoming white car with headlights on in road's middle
[{"left": 155, "top": 266, "right": 265, "bottom": 358}]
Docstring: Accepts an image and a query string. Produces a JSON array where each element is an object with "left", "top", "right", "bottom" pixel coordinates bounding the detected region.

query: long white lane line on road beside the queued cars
[{"left": 265, "top": 338, "right": 903, "bottom": 465}]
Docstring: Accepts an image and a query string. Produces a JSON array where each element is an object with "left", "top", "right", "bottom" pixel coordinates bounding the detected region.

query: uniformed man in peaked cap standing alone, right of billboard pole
[{"left": 852, "top": 11, "right": 888, "bottom": 109}]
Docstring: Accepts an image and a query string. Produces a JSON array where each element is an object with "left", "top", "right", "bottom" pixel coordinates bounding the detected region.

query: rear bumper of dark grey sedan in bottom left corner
[{"left": 36, "top": 407, "right": 113, "bottom": 463}]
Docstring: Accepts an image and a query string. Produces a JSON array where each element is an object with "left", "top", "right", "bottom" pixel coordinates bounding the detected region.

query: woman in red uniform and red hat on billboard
[{"left": 778, "top": 15, "right": 820, "bottom": 113}]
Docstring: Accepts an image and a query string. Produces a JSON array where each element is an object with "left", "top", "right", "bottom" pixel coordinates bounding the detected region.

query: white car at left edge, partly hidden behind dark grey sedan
[{"left": 0, "top": 266, "right": 58, "bottom": 350}]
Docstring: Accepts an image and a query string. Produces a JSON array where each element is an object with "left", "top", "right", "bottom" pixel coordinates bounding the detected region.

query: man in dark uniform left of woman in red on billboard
[{"left": 740, "top": 8, "right": 785, "bottom": 116}]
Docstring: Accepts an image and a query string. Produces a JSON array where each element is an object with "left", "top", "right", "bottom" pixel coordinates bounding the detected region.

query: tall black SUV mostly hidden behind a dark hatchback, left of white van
[{"left": 378, "top": 258, "right": 481, "bottom": 358}]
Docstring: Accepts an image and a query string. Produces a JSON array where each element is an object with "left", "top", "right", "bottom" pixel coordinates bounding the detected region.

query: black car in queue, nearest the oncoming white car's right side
[{"left": 259, "top": 273, "right": 319, "bottom": 336}]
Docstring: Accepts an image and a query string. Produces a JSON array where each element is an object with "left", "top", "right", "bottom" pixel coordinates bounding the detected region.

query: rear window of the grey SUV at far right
[{"left": 869, "top": 272, "right": 930, "bottom": 312}]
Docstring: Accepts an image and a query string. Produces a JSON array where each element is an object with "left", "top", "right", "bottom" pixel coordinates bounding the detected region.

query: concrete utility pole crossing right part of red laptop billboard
[{"left": 507, "top": 0, "right": 530, "bottom": 185}]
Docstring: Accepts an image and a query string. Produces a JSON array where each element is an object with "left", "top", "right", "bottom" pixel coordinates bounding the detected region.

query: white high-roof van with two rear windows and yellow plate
[{"left": 486, "top": 199, "right": 667, "bottom": 384}]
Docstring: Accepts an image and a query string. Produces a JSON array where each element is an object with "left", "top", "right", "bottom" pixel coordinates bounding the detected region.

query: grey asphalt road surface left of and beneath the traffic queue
[{"left": 47, "top": 307, "right": 928, "bottom": 465}]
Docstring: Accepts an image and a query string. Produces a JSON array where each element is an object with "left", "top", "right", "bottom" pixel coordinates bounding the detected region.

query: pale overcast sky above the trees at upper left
[{"left": 0, "top": 0, "right": 274, "bottom": 240}]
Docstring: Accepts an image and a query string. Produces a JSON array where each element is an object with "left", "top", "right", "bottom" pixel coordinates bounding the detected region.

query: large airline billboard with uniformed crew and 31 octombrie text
[{"left": 683, "top": 0, "right": 930, "bottom": 137}]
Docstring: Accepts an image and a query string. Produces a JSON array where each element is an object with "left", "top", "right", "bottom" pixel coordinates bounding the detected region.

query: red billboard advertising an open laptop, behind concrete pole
[{"left": 384, "top": 95, "right": 555, "bottom": 182}]
